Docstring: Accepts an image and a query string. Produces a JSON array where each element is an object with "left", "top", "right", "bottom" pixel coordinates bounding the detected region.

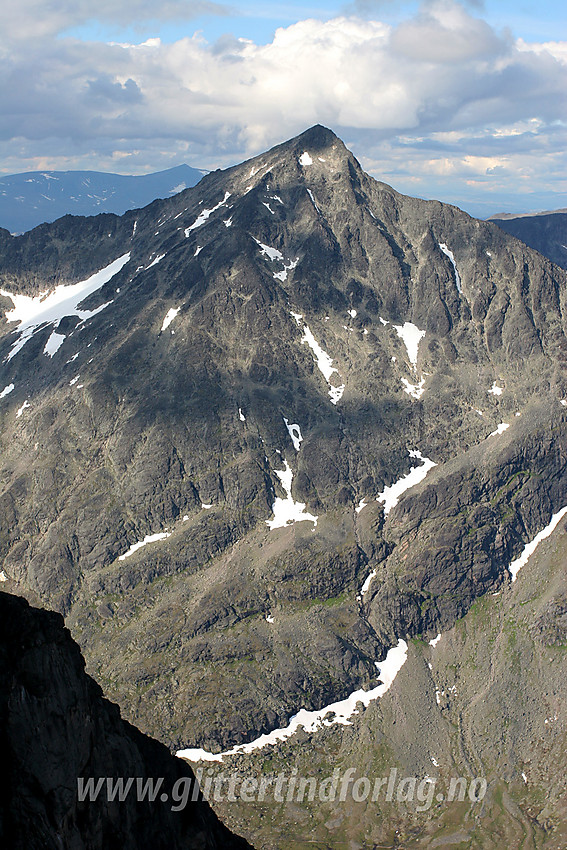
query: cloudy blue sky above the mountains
[{"left": 0, "top": 0, "right": 567, "bottom": 217}]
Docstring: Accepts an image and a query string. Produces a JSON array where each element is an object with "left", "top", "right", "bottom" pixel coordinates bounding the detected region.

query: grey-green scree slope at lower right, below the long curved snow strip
[{"left": 207, "top": 510, "right": 567, "bottom": 850}]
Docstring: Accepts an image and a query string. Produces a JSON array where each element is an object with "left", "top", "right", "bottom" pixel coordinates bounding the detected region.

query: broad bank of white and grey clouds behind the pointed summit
[{"left": 0, "top": 0, "right": 567, "bottom": 214}]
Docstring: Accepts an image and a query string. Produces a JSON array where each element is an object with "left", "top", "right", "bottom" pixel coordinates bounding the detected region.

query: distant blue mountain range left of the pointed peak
[{"left": 0, "top": 165, "right": 208, "bottom": 233}]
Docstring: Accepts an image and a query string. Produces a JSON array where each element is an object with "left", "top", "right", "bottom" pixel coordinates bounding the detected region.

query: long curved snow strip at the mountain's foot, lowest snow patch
[{"left": 176, "top": 640, "right": 408, "bottom": 762}]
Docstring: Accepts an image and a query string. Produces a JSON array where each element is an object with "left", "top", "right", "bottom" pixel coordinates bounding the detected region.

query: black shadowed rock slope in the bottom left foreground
[{"left": 0, "top": 592, "right": 250, "bottom": 850}]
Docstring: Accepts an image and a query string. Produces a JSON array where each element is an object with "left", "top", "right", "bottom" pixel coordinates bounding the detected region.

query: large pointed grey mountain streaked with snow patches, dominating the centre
[{"left": 0, "top": 122, "right": 567, "bottom": 846}]
